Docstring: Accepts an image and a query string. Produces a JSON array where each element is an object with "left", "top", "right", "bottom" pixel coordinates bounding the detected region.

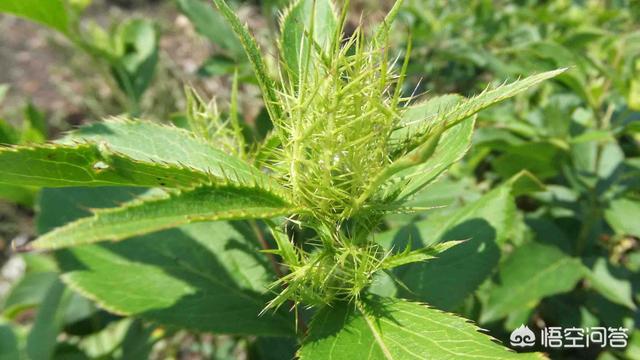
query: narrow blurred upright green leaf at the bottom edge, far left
[{"left": 27, "top": 280, "right": 71, "bottom": 360}]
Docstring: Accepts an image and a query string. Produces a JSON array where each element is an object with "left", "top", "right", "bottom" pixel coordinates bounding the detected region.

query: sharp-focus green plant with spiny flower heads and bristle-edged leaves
[{"left": 0, "top": 0, "right": 564, "bottom": 359}]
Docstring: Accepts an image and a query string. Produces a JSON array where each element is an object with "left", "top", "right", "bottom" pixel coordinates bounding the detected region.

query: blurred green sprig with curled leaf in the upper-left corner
[{"left": 0, "top": 0, "right": 158, "bottom": 116}]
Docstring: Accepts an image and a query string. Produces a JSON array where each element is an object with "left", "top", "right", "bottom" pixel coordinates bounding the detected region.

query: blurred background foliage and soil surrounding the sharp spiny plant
[{"left": 0, "top": 0, "right": 640, "bottom": 359}]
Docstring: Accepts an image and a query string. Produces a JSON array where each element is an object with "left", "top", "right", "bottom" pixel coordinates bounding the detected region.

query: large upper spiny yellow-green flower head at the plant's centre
[{"left": 275, "top": 30, "right": 410, "bottom": 224}]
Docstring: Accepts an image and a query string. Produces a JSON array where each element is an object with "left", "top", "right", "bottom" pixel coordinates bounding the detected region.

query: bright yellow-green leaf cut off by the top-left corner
[{"left": 0, "top": 0, "right": 69, "bottom": 35}]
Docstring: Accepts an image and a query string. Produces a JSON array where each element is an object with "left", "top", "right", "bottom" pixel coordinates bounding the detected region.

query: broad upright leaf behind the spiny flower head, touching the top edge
[{"left": 280, "top": 0, "right": 338, "bottom": 84}]
